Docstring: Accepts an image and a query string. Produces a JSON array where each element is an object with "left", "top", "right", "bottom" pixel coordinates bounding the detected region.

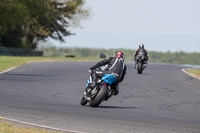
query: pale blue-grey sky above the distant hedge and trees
[{"left": 48, "top": 0, "right": 200, "bottom": 52}]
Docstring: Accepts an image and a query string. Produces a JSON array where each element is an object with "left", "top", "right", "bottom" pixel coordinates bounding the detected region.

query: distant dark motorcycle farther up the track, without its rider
[{"left": 136, "top": 53, "right": 147, "bottom": 74}]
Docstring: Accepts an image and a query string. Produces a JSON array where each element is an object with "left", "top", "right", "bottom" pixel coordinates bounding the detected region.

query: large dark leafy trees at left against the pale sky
[{"left": 0, "top": 0, "right": 89, "bottom": 49}]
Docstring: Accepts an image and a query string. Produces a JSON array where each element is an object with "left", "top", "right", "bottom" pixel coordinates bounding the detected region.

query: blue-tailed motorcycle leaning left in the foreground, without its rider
[{"left": 80, "top": 71, "right": 116, "bottom": 107}]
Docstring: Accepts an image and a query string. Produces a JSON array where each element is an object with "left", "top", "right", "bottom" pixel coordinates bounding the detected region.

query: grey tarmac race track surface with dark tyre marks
[{"left": 0, "top": 61, "right": 200, "bottom": 133}]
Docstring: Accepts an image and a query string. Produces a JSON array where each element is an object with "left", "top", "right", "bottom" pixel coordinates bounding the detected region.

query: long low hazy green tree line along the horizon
[{"left": 38, "top": 47, "right": 200, "bottom": 65}]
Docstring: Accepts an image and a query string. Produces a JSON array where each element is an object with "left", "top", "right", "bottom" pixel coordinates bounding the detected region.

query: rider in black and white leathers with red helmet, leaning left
[{"left": 90, "top": 51, "right": 127, "bottom": 95}]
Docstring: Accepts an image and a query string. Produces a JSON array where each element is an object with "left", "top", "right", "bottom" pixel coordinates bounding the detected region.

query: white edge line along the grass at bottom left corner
[{"left": 0, "top": 116, "right": 84, "bottom": 133}]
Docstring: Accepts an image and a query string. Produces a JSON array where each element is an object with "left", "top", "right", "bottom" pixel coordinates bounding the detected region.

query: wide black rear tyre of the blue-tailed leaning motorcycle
[{"left": 90, "top": 85, "right": 108, "bottom": 107}]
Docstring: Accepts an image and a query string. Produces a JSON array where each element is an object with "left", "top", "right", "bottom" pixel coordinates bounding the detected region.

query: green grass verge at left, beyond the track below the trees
[{"left": 0, "top": 56, "right": 100, "bottom": 72}]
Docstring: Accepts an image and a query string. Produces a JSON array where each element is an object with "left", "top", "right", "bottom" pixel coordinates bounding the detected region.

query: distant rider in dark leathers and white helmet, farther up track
[{"left": 134, "top": 44, "right": 149, "bottom": 68}]
